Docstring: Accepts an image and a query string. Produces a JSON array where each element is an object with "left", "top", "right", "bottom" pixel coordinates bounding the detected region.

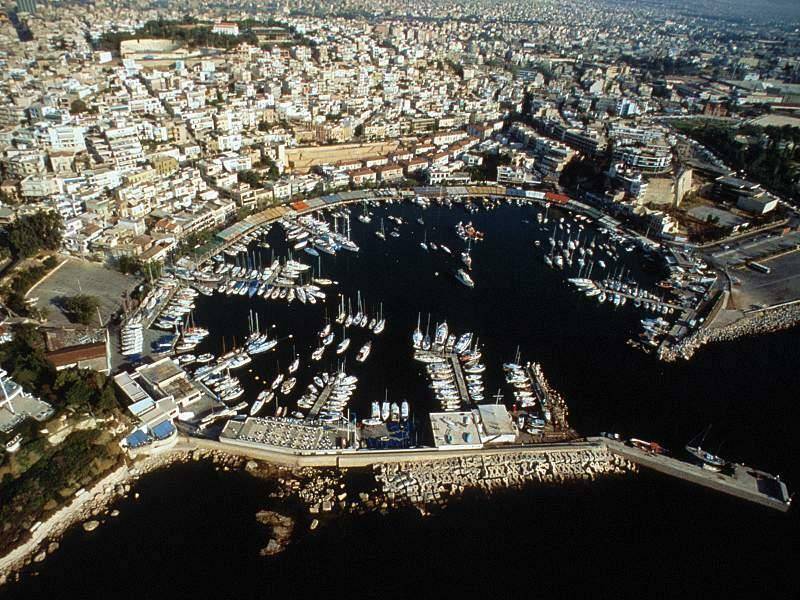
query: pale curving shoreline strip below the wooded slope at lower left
[{"left": 0, "top": 445, "right": 243, "bottom": 586}]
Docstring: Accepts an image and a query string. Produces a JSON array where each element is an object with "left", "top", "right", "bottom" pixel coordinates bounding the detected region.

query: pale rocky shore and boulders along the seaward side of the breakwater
[{"left": 0, "top": 447, "right": 637, "bottom": 585}]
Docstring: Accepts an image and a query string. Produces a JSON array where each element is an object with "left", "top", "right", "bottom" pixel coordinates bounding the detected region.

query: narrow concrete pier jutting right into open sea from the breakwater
[{"left": 588, "top": 438, "right": 791, "bottom": 512}]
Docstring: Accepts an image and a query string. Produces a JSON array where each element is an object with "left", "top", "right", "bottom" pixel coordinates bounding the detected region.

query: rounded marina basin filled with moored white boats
[{"left": 106, "top": 192, "right": 792, "bottom": 516}]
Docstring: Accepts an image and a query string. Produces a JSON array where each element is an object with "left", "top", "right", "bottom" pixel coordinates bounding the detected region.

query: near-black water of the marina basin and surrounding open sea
[{"left": 0, "top": 205, "right": 800, "bottom": 598}]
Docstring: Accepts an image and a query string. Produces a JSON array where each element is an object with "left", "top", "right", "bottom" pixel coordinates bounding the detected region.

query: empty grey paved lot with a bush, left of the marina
[{"left": 28, "top": 258, "right": 138, "bottom": 326}]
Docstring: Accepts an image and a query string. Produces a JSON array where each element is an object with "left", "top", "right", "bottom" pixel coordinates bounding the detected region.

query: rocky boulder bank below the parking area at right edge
[{"left": 659, "top": 304, "right": 800, "bottom": 362}]
